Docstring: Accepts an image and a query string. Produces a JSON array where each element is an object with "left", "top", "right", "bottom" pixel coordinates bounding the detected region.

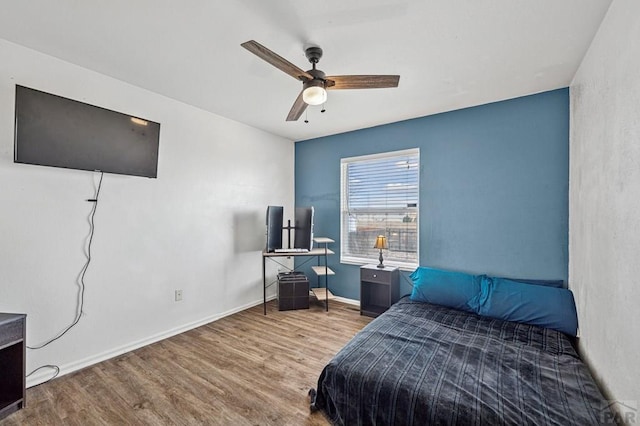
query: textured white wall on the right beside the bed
[{"left": 569, "top": 0, "right": 640, "bottom": 408}]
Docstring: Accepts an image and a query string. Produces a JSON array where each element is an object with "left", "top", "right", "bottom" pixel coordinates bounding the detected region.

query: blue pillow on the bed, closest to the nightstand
[{"left": 410, "top": 266, "right": 481, "bottom": 313}]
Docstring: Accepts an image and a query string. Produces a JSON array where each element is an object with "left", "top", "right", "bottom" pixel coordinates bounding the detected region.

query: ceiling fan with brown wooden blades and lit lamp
[{"left": 241, "top": 40, "right": 400, "bottom": 121}]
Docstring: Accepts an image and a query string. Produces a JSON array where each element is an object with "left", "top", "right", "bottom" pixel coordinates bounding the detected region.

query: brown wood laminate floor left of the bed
[{"left": 0, "top": 302, "right": 371, "bottom": 426}]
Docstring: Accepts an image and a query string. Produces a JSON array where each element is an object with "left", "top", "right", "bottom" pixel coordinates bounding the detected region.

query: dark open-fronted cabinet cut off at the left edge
[{"left": 0, "top": 313, "right": 26, "bottom": 419}]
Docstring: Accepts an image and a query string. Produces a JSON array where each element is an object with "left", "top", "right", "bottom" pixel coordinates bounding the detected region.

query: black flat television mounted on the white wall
[{"left": 14, "top": 85, "right": 160, "bottom": 178}]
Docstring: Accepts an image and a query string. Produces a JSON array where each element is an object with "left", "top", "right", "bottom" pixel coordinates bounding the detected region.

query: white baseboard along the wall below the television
[{"left": 27, "top": 296, "right": 275, "bottom": 388}]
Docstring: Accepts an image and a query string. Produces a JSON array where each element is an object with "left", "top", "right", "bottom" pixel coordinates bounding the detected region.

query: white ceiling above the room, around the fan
[{"left": 0, "top": 0, "right": 611, "bottom": 140}]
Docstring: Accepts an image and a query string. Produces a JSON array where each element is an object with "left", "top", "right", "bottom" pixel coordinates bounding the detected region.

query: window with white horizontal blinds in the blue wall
[{"left": 340, "top": 149, "right": 420, "bottom": 269}]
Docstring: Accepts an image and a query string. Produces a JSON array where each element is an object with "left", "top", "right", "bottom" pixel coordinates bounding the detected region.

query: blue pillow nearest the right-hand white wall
[{"left": 477, "top": 276, "right": 578, "bottom": 336}]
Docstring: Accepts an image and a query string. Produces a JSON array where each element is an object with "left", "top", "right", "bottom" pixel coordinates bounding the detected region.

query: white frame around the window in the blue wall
[{"left": 340, "top": 148, "right": 420, "bottom": 271}]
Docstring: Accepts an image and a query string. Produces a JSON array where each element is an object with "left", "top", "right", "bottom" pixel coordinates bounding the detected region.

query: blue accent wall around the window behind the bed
[{"left": 295, "top": 89, "right": 569, "bottom": 299}]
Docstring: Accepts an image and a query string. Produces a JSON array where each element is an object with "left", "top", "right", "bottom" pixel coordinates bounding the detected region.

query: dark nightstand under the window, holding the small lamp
[{"left": 360, "top": 265, "right": 400, "bottom": 317}]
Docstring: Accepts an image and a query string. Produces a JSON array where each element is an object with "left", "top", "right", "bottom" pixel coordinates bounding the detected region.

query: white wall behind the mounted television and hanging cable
[{"left": 0, "top": 40, "right": 294, "bottom": 385}]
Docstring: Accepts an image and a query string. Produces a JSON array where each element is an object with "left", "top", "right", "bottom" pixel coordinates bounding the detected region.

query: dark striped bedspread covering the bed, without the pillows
[{"left": 310, "top": 297, "right": 606, "bottom": 425}]
